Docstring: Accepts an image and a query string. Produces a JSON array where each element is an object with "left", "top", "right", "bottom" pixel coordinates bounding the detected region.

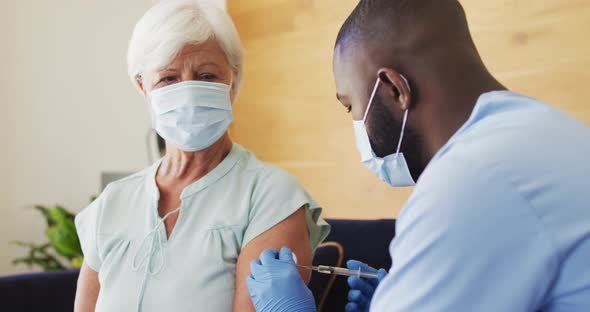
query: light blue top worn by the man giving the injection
[{"left": 371, "top": 91, "right": 590, "bottom": 312}]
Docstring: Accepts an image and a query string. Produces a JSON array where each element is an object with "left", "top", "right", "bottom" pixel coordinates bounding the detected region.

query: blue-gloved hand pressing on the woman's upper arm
[{"left": 246, "top": 247, "right": 316, "bottom": 312}]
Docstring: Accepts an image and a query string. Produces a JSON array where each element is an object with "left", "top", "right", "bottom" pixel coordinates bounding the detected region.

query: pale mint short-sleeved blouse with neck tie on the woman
[{"left": 76, "top": 144, "right": 329, "bottom": 312}]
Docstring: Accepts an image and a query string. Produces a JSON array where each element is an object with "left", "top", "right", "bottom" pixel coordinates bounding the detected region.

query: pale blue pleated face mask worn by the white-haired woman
[{"left": 150, "top": 81, "right": 233, "bottom": 152}]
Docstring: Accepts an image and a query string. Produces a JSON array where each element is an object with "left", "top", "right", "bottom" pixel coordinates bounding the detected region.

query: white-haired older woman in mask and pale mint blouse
[{"left": 75, "top": 1, "right": 329, "bottom": 312}]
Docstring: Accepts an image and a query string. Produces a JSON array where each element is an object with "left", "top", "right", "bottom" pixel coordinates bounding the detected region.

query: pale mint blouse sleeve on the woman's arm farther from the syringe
[{"left": 75, "top": 192, "right": 104, "bottom": 272}]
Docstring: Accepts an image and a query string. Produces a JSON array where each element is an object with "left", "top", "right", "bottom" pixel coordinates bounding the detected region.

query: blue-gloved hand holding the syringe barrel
[{"left": 346, "top": 260, "right": 387, "bottom": 312}]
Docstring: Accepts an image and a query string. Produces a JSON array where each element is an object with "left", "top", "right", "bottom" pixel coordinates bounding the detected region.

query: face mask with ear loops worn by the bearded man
[{"left": 352, "top": 76, "right": 416, "bottom": 187}]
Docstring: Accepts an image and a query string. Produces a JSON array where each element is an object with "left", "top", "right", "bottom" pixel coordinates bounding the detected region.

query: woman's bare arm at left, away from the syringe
[{"left": 74, "top": 262, "right": 100, "bottom": 312}]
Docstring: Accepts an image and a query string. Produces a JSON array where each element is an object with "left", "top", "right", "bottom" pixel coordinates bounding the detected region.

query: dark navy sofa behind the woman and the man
[{"left": 0, "top": 219, "right": 395, "bottom": 312}]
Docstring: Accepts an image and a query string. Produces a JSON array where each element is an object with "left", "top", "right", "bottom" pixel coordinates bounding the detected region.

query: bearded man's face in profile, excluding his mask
[{"left": 333, "top": 46, "right": 427, "bottom": 180}]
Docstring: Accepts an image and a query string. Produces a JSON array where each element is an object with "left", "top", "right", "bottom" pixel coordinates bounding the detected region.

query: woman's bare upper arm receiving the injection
[{"left": 233, "top": 208, "right": 312, "bottom": 312}]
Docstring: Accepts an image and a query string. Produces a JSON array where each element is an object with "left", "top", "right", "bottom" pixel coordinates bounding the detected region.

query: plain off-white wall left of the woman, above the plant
[{"left": 0, "top": 0, "right": 153, "bottom": 274}]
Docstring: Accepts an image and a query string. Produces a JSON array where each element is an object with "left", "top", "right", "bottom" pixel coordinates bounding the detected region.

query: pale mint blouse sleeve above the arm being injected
[{"left": 242, "top": 168, "right": 330, "bottom": 251}]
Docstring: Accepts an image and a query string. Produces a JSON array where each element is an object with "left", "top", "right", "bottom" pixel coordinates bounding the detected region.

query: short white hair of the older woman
[{"left": 127, "top": 0, "right": 243, "bottom": 94}]
